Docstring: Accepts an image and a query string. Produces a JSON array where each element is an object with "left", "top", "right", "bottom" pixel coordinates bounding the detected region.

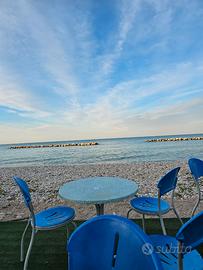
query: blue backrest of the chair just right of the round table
[{"left": 157, "top": 167, "right": 180, "bottom": 196}]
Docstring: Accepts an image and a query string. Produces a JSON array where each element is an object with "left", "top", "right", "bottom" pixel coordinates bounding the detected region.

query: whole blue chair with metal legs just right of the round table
[{"left": 127, "top": 167, "right": 183, "bottom": 235}]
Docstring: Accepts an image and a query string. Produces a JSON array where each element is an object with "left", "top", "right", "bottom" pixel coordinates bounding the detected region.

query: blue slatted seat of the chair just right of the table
[{"left": 130, "top": 197, "right": 170, "bottom": 215}]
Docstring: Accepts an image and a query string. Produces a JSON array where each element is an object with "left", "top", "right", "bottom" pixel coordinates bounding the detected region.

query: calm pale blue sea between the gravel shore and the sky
[{"left": 0, "top": 134, "right": 203, "bottom": 167}]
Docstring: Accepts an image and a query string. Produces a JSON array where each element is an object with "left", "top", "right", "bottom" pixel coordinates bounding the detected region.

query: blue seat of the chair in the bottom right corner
[{"left": 150, "top": 235, "right": 203, "bottom": 270}]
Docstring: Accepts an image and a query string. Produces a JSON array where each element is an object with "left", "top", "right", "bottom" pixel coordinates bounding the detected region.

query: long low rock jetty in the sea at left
[{"left": 10, "top": 142, "right": 98, "bottom": 149}]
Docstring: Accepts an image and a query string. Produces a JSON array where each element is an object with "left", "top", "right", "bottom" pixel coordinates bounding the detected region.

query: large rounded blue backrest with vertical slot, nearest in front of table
[{"left": 67, "top": 215, "right": 163, "bottom": 270}]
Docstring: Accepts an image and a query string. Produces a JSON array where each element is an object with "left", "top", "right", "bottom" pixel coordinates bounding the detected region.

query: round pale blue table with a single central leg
[{"left": 59, "top": 177, "right": 138, "bottom": 215}]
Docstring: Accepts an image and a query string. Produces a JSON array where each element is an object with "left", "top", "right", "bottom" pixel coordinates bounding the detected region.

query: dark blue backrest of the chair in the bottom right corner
[{"left": 176, "top": 211, "right": 203, "bottom": 250}]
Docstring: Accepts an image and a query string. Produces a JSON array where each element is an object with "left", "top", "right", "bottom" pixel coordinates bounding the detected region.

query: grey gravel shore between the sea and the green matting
[{"left": 0, "top": 161, "right": 203, "bottom": 221}]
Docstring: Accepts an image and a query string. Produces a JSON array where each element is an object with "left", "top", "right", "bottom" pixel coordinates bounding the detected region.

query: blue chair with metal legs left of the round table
[{"left": 13, "top": 176, "right": 75, "bottom": 270}]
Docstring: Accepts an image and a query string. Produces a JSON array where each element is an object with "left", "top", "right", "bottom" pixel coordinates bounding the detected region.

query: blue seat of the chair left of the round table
[{"left": 32, "top": 206, "right": 75, "bottom": 230}]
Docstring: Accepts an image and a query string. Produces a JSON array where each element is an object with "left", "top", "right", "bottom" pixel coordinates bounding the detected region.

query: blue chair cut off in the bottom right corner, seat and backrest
[{"left": 150, "top": 211, "right": 203, "bottom": 270}]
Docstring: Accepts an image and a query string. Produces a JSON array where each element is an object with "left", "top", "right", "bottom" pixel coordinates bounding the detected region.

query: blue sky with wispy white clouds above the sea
[{"left": 0, "top": 0, "right": 203, "bottom": 144}]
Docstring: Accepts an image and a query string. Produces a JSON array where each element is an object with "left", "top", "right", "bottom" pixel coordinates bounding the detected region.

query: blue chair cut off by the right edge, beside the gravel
[{"left": 188, "top": 158, "right": 203, "bottom": 216}]
